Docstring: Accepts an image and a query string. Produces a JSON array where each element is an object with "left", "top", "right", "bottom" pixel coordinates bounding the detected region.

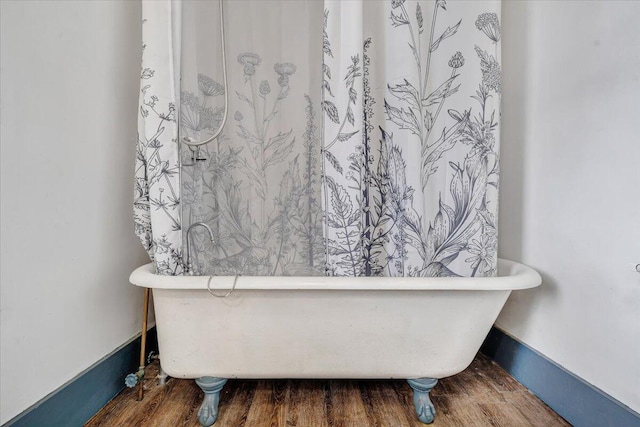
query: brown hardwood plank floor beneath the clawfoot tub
[{"left": 86, "top": 354, "right": 570, "bottom": 427}]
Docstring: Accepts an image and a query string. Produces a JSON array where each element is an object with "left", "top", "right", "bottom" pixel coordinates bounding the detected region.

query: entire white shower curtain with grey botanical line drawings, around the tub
[{"left": 134, "top": 0, "right": 501, "bottom": 276}]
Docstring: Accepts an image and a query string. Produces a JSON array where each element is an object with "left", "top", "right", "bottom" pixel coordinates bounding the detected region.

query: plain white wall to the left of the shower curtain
[{"left": 0, "top": 0, "right": 148, "bottom": 424}]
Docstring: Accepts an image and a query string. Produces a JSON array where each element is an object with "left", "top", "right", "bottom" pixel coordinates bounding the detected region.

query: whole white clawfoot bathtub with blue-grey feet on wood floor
[{"left": 130, "top": 259, "right": 541, "bottom": 426}]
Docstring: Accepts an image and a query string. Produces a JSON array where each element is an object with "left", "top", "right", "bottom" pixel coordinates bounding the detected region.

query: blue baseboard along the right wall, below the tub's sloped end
[{"left": 480, "top": 327, "right": 640, "bottom": 427}]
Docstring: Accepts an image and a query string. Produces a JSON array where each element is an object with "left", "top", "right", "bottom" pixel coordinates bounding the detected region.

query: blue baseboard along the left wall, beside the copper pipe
[{"left": 3, "top": 327, "right": 158, "bottom": 427}]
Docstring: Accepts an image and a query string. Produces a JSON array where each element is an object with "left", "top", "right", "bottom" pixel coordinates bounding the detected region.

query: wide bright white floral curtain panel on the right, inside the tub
[{"left": 323, "top": 0, "right": 500, "bottom": 276}]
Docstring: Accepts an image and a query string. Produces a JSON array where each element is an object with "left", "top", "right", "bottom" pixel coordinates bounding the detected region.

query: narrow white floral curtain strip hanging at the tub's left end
[{"left": 133, "top": 1, "right": 183, "bottom": 275}]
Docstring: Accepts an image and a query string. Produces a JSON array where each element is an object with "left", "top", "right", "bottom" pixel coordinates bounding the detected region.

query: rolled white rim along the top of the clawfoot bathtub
[{"left": 129, "top": 258, "right": 542, "bottom": 291}]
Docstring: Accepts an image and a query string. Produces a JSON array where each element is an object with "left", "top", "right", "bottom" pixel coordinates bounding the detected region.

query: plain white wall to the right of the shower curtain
[{"left": 498, "top": 1, "right": 640, "bottom": 411}]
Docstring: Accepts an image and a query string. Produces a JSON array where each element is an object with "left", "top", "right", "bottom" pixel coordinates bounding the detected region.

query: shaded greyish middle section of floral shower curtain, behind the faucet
[{"left": 180, "top": 0, "right": 325, "bottom": 275}]
